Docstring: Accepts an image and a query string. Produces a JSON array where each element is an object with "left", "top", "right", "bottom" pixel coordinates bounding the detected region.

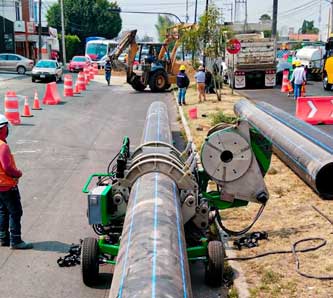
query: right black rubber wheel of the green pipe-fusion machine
[{"left": 205, "top": 241, "right": 224, "bottom": 287}]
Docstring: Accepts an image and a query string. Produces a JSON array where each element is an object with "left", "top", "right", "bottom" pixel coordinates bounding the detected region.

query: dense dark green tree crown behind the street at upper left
[{"left": 46, "top": 0, "right": 122, "bottom": 41}]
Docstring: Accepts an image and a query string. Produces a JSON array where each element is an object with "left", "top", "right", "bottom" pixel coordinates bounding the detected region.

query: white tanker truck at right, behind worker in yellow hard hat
[{"left": 296, "top": 46, "right": 326, "bottom": 80}]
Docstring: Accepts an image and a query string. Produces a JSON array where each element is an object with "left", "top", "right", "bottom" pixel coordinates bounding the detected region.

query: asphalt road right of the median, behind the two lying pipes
[{"left": 237, "top": 81, "right": 333, "bottom": 135}]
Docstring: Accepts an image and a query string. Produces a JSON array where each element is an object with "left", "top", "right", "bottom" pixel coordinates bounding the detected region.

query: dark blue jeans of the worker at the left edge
[{"left": 0, "top": 186, "right": 23, "bottom": 245}]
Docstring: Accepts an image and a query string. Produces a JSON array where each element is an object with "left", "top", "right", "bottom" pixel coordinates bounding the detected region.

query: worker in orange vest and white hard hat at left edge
[{"left": 0, "top": 114, "right": 32, "bottom": 249}]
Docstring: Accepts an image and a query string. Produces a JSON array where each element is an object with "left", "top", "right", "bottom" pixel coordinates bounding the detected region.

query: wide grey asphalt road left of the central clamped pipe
[{"left": 0, "top": 77, "right": 220, "bottom": 298}]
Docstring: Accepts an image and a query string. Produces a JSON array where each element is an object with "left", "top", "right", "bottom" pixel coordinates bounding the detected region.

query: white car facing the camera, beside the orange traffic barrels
[{"left": 31, "top": 60, "right": 63, "bottom": 82}]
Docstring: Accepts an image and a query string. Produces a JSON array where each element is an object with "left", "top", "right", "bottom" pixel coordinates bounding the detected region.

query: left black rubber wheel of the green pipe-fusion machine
[{"left": 81, "top": 237, "right": 99, "bottom": 286}]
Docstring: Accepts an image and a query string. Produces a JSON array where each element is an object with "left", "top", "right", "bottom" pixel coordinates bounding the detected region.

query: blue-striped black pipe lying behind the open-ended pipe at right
[{"left": 256, "top": 101, "right": 333, "bottom": 154}]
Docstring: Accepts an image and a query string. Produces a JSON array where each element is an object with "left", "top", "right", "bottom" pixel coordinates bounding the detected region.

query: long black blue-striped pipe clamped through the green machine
[{"left": 109, "top": 102, "right": 192, "bottom": 298}]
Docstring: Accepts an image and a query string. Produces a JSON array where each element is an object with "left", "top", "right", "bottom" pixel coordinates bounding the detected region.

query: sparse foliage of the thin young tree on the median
[{"left": 182, "top": 4, "right": 227, "bottom": 58}]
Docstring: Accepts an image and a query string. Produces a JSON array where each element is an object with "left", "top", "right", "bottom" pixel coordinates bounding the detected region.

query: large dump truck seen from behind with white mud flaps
[{"left": 225, "top": 33, "right": 276, "bottom": 89}]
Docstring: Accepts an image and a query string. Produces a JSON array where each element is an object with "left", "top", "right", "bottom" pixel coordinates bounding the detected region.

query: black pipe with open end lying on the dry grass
[{"left": 234, "top": 99, "right": 333, "bottom": 198}]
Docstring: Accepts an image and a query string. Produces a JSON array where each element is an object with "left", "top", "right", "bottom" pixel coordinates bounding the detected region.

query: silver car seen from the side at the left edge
[{"left": 0, "top": 53, "right": 34, "bottom": 74}]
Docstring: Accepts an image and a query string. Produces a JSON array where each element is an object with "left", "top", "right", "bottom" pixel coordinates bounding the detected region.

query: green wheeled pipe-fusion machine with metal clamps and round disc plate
[{"left": 82, "top": 121, "right": 272, "bottom": 286}]
